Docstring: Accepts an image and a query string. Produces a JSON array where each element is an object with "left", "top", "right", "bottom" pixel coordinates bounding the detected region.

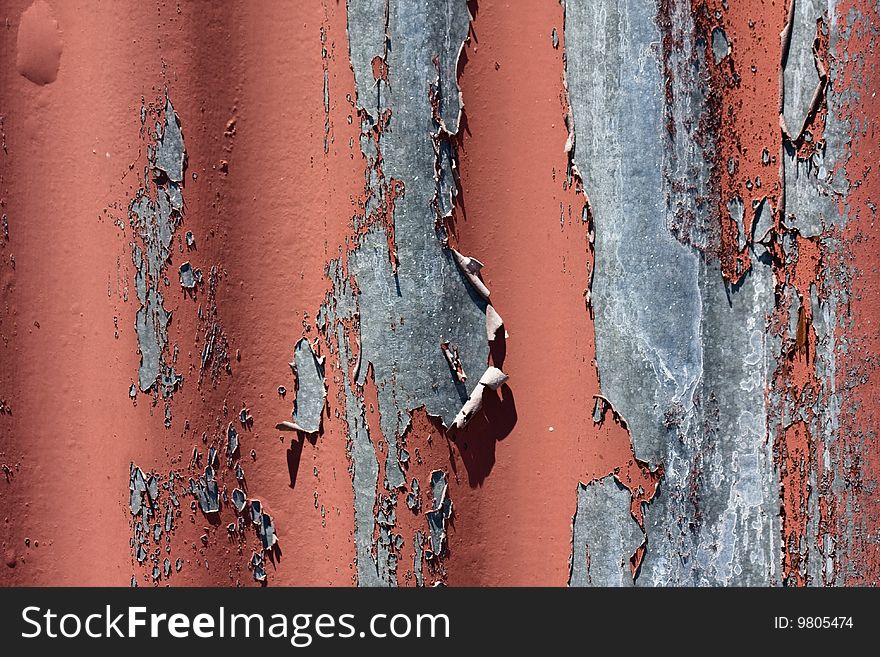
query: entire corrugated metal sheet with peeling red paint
[{"left": 0, "top": 0, "right": 880, "bottom": 586}]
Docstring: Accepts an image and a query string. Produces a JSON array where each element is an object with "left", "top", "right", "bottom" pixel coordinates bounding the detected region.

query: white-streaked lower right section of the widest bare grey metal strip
[{"left": 637, "top": 256, "right": 782, "bottom": 586}]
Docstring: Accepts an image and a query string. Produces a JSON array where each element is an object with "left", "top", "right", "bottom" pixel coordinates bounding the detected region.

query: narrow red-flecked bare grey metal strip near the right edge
[{"left": 770, "top": 0, "right": 856, "bottom": 585}]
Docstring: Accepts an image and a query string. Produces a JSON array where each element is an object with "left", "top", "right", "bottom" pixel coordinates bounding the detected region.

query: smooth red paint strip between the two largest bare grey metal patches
[{"left": 444, "top": 3, "right": 654, "bottom": 585}]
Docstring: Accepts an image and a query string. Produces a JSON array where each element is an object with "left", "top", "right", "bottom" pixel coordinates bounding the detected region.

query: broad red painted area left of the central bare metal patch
[{"left": 0, "top": 2, "right": 363, "bottom": 585}]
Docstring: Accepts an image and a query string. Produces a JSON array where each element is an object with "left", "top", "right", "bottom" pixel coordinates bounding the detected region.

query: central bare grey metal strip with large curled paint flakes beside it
[{"left": 336, "top": 0, "right": 488, "bottom": 585}]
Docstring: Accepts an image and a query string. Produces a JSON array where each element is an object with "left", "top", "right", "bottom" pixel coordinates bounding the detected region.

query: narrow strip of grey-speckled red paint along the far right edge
[{"left": 834, "top": 0, "right": 880, "bottom": 585}]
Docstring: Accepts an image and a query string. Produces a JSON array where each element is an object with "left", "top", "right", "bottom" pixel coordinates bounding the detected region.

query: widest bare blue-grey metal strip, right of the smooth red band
[{"left": 565, "top": 0, "right": 781, "bottom": 585}]
